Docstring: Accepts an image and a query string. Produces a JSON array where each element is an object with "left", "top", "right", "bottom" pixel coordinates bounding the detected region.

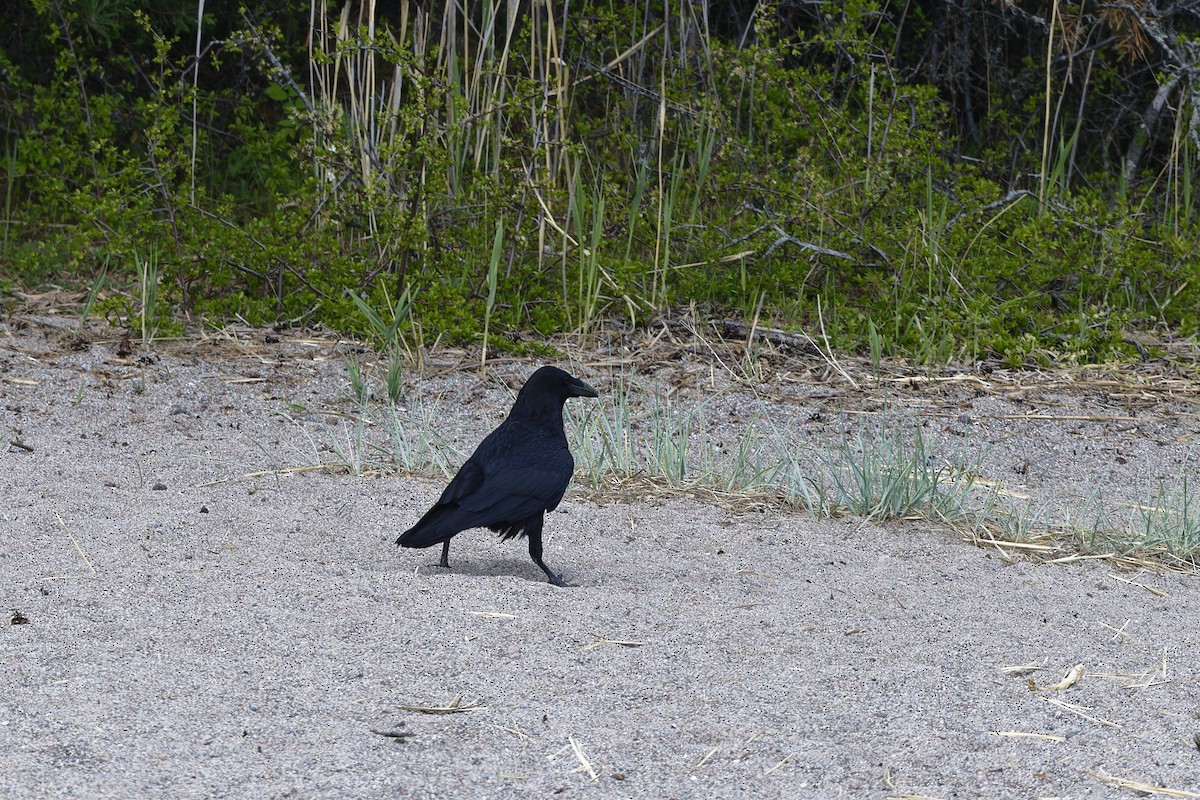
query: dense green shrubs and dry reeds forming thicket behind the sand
[{"left": 0, "top": 0, "right": 1200, "bottom": 365}]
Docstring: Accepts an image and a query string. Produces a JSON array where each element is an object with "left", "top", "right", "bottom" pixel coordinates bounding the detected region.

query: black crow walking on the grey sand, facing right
[{"left": 396, "top": 367, "right": 599, "bottom": 587}]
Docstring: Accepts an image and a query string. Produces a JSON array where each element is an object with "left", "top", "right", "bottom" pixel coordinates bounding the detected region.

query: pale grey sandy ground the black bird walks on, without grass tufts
[{"left": 0, "top": 319, "right": 1200, "bottom": 798}]
